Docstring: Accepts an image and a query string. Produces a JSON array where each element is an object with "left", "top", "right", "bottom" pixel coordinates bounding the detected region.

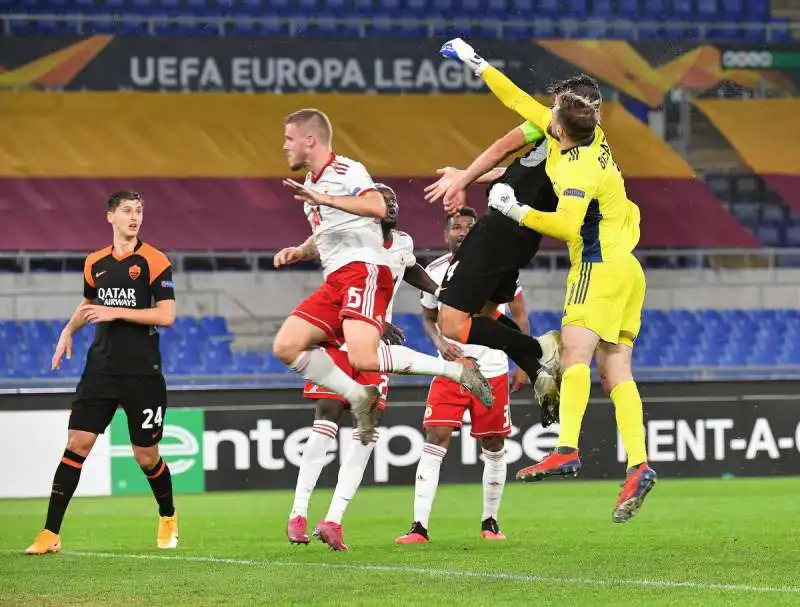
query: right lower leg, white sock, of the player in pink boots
[{"left": 314, "top": 430, "right": 380, "bottom": 551}]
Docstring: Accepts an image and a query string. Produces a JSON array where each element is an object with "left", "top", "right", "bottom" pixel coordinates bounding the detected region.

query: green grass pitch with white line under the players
[{"left": 0, "top": 478, "right": 800, "bottom": 606}]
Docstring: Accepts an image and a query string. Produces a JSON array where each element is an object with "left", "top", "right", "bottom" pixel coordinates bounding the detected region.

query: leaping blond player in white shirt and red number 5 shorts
[{"left": 273, "top": 109, "right": 492, "bottom": 444}]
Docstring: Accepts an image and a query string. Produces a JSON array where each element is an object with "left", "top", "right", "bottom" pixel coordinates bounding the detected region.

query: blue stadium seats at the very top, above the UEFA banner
[{"left": 1, "top": 0, "right": 790, "bottom": 42}]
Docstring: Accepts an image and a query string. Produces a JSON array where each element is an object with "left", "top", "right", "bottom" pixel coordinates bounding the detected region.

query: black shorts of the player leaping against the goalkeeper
[{"left": 439, "top": 209, "right": 542, "bottom": 314}]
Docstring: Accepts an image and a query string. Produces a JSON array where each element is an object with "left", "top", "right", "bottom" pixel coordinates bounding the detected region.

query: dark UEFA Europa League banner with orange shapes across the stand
[{"left": 0, "top": 36, "right": 800, "bottom": 95}]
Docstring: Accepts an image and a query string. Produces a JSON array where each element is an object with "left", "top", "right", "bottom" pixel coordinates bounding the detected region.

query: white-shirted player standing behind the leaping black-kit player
[{"left": 395, "top": 207, "right": 529, "bottom": 544}]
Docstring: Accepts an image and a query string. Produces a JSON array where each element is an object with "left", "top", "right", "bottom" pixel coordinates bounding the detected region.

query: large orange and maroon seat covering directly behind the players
[{"left": 0, "top": 92, "right": 758, "bottom": 251}]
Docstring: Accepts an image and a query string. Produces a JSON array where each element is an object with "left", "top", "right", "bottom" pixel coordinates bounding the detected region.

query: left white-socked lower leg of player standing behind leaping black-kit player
[{"left": 394, "top": 436, "right": 453, "bottom": 544}]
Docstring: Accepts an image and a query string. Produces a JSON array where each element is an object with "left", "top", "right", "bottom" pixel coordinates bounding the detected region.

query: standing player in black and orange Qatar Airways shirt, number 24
[{"left": 25, "top": 191, "right": 178, "bottom": 554}]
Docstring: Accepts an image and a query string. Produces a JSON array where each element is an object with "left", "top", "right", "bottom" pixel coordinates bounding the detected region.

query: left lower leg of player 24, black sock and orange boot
[{"left": 25, "top": 430, "right": 97, "bottom": 555}]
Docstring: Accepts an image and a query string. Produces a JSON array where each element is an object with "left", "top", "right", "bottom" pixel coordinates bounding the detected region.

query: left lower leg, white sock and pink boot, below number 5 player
[{"left": 286, "top": 416, "right": 340, "bottom": 544}]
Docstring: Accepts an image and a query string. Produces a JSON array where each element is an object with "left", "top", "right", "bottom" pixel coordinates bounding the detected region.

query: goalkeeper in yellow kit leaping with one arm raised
[{"left": 442, "top": 38, "right": 657, "bottom": 522}]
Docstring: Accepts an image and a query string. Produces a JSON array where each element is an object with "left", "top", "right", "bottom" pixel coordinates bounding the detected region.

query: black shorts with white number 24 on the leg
[{"left": 69, "top": 374, "right": 167, "bottom": 447}]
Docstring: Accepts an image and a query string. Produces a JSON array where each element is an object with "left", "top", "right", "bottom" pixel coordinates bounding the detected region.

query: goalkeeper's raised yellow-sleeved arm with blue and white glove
[{"left": 440, "top": 38, "right": 552, "bottom": 132}]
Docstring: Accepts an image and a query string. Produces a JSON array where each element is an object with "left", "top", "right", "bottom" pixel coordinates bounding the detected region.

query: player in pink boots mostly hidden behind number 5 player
[{"left": 276, "top": 184, "right": 438, "bottom": 550}]
